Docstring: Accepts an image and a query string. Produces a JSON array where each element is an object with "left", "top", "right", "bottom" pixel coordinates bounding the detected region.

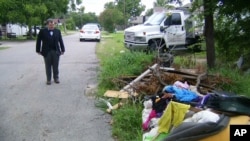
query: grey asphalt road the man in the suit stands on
[{"left": 0, "top": 34, "right": 113, "bottom": 141}]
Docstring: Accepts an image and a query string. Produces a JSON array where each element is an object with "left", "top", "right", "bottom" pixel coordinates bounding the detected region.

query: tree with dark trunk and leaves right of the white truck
[{"left": 190, "top": 0, "right": 250, "bottom": 68}]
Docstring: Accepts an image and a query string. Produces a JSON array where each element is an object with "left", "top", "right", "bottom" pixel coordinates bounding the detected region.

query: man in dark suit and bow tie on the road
[{"left": 36, "top": 19, "right": 65, "bottom": 85}]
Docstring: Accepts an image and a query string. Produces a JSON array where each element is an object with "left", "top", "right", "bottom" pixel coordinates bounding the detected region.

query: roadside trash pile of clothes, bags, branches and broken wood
[{"left": 104, "top": 64, "right": 250, "bottom": 141}]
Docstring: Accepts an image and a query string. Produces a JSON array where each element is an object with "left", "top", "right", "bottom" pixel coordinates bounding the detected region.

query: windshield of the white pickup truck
[{"left": 144, "top": 12, "right": 166, "bottom": 25}]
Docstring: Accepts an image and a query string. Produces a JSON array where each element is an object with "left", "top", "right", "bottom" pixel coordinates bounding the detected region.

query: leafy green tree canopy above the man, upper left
[{"left": 0, "top": 0, "right": 81, "bottom": 36}]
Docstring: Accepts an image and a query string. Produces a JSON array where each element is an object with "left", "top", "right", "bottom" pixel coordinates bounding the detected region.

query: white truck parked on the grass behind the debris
[{"left": 124, "top": 10, "right": 203, "bottom": 51}]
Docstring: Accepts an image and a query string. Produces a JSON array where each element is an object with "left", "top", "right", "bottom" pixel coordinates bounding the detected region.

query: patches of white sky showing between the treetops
[{"left": 82, "top": 0, "right": 155, "bottom": 15}]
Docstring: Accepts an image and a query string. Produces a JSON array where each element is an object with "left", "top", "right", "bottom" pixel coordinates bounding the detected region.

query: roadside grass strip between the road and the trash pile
[{"left": 96, "top": 33, "right": 153, "bottom": 141}]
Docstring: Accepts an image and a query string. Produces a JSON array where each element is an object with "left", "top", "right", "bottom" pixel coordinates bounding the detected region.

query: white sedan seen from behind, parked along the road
[{"left": 79, "top": 24, "right": 101, "bottom": 42}]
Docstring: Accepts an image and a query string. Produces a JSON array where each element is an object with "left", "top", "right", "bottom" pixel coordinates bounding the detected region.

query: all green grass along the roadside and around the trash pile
[{"left": 96, "top": 33, "right": 250, "bottom": 141}]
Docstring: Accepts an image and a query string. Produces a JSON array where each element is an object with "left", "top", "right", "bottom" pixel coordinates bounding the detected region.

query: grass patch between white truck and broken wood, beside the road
[{"left": 97, "top": 33, "right": 153, "bottom": 93}]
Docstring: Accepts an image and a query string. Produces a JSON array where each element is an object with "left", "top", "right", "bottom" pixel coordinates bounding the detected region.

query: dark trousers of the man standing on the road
[{"left": 44, "top": 50, "right": 60, "bottom": 81}]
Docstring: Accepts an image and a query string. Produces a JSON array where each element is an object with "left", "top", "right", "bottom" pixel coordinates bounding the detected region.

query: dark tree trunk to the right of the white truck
[{"left": 204, "top": 0, "right": 215, "bottom": 68}]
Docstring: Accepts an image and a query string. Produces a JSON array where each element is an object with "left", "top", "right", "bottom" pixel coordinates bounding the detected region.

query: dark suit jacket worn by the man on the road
[{"left": 36, "top": 28, "right": 65, "bottom": 57}]
